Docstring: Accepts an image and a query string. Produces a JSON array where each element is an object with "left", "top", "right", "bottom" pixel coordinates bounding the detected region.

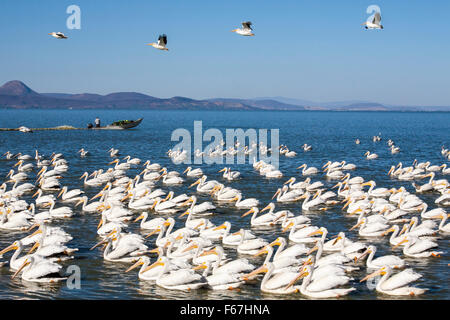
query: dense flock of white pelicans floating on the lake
[{"left": 0, "top": 139, "right": 450, "bottom": 298}]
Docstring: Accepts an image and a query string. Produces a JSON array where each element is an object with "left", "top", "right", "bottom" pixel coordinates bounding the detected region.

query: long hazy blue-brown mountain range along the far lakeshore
[{"left": 0, "top": 80, "right": 450, "bottom": 111}]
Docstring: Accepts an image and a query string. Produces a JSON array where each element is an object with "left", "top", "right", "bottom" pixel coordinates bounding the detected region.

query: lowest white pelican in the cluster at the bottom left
[{"left": 12, "top": 256, "right": 67, "bottom": 283}]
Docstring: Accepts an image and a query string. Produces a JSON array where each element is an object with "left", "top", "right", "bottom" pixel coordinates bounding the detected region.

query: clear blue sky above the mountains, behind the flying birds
[{"left": 0, "top": 0, "right": 450, "bottom": 105}]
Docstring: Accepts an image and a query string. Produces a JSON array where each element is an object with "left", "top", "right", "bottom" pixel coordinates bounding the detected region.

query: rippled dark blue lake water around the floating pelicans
[{"left": 0, "top": 110, "right": 450, "bottom": 299}]
